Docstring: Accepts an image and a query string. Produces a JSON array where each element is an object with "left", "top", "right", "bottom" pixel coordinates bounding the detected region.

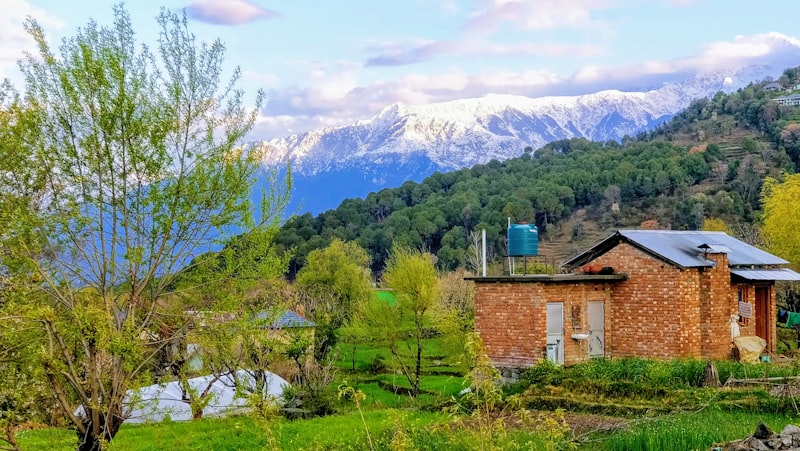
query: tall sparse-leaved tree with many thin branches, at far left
[{"left": 0, "top": 6, "right": 285, "bottom": 450}]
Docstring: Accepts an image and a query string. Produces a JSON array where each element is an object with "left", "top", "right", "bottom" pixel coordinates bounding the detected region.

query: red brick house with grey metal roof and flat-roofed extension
[{"left": 470, "top": 230, "right": 800, "bottom": 368}]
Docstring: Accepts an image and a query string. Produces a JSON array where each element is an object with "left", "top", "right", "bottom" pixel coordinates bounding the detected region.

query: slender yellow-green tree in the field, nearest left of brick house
[{"left": 359, "top": 247, "right": 439, "bottom": 397}]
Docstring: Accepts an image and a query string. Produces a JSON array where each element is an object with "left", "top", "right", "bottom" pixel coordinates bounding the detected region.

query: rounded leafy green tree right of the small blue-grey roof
[{"left": 295, "top": 239, "right": 372, "bottom": 361}]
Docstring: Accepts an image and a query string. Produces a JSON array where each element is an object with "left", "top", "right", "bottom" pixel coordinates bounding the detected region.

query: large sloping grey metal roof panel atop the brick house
[{"left": 618, "top": 230, "right": 788, "bottom": 268}]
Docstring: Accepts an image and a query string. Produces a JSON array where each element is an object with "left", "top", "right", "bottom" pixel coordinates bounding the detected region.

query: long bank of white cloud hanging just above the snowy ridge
[{"left": 254, "top": 33, "right": 800, "bottom": 138}]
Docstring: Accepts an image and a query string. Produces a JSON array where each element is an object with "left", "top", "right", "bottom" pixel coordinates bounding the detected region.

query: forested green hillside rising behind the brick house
[{"left": 276, "top": 69, "right": 800, "bottom": 277}]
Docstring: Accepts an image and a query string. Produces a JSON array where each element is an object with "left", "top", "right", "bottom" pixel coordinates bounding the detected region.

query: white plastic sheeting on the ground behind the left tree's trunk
[{"left": 125, "top": 371, "right": 289, "bottom": 423}]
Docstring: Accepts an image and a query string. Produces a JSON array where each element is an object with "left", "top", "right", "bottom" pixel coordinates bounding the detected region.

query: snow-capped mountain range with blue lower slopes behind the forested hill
[{"left": 265, "top": 59, "right": 800, "bottom": 213}]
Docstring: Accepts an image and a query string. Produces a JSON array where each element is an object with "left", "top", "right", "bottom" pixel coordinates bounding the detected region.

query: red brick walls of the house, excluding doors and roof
[{"left": 475, "top": 243, "right": 776, "bottom": 368}]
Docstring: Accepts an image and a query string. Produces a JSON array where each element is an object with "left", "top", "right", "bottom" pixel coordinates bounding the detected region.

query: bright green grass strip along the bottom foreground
[{"left": 18, "top": 408, "right": 797, "bottom": 451}]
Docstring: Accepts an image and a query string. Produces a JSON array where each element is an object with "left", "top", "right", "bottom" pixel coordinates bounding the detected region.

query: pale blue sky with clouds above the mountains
[{"left": 0, "top": 0, "right": 800, "bottom": 139}]
